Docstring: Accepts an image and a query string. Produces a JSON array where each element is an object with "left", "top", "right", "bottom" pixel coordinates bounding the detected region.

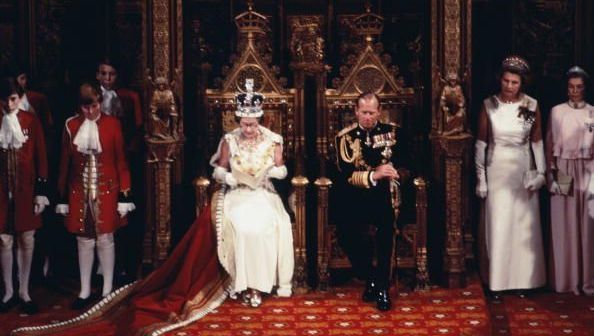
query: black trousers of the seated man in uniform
[{"left": 337, "top": 198, "right": 395, "bottom": 289}]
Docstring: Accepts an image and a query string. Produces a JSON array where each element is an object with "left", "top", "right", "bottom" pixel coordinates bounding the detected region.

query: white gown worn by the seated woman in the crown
[{"left": 211, "top": 126, "right": 294, "bottom": 296}]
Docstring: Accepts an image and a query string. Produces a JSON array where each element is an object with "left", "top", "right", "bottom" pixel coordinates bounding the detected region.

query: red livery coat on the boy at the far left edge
[{"left": 0, "top": 111, "right": 47, "bottom": 233}]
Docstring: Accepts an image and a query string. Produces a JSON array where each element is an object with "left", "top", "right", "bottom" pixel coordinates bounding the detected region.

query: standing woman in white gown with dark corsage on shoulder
[{"left": 475, "top": 56, "right": 546, "bottom": 291}]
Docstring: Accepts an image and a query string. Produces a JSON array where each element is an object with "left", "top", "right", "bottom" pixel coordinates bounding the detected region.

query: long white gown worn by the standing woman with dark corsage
[{"left": 485, "top": 96, "right": 546, "bottom": 291}]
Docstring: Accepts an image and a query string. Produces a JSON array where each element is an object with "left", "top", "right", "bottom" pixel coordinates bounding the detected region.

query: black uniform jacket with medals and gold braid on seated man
[{"left": 336, "top": 122, "right": 410, "bottom": 220}]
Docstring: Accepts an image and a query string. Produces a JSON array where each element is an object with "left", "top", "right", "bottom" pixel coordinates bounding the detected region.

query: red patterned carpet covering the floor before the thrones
[{"left": 0, "top": 280, "right": 594, "bottom": 336}]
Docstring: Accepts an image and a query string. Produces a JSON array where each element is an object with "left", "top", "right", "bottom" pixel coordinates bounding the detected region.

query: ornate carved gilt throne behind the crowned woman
[{"left": 196, "top": 6, "right": 307, "bottom": 292}]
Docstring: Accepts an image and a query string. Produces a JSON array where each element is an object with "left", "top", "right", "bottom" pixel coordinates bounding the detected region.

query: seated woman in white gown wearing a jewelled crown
[{"left": 210, "top": 79, "right": 294, "bottom": 307}]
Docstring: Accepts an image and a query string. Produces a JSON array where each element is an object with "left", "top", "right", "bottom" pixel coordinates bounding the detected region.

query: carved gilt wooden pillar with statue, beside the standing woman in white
[{"left": 430, "top": 0, "right": 472, "bottom": 287}]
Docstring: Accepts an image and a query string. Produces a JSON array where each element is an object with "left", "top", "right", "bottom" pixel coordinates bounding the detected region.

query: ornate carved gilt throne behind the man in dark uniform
[{"left": 316, "top": 8, "right": 428, "bottom": 289}]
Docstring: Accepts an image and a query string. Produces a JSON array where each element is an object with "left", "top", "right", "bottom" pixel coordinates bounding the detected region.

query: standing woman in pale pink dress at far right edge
[{"left": 547, "top": 66, "right": 594, "bottom": 295}]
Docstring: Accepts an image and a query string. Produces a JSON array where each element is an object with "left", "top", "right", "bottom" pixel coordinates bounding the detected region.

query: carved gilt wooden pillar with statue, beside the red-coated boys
[{"left": 143, "top": 0, "right": 185, "bottom": 266}]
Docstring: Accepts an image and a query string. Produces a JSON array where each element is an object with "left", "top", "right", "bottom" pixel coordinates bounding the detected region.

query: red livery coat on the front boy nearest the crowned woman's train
[{"left": 58, "top": 113, "right": 130, "bottom": 234}]
